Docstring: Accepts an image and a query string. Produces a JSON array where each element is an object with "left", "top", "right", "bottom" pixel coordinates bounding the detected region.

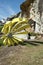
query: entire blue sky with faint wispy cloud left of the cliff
[{"left": 0, "top": 0, "right": 25, "bottom": 19}]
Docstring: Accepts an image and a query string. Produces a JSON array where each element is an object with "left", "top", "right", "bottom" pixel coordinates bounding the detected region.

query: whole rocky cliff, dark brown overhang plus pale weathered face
[{"left": 20, "top": 0, "right": 43, "bottom": 33}]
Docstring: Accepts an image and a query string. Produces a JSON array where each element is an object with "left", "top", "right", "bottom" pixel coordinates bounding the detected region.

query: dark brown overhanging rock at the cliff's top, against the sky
[{"left": 20, "top": 0, "right": 34, "bottom": 17}]
